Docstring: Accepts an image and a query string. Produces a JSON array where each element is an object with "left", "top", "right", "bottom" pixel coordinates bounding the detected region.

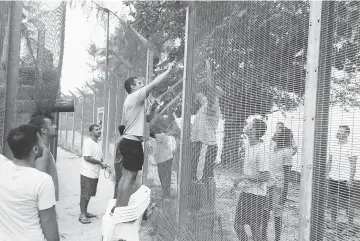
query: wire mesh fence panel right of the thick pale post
[{"left": 314, "top": 1, "right": 360, "bottom": 240}]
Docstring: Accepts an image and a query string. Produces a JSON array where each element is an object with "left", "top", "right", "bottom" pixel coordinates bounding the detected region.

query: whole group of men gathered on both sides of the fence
[{"left": 0, "top": 58, "right": 360, "bottom": 241}]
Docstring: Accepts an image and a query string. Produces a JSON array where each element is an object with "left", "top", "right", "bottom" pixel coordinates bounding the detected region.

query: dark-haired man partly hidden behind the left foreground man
[{"left": 29, "top": 115, "right": 59, "bottom": 201}]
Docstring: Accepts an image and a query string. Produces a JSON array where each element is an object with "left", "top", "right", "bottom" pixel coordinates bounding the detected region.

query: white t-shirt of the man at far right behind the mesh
[{"left": 329, "top": 141, "right": 357, "bottom": 181}]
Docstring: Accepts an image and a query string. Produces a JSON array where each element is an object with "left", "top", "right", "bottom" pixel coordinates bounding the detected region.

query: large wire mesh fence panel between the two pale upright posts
[{"left": 177, "top": 2, "right": 309, "bottom": 240}]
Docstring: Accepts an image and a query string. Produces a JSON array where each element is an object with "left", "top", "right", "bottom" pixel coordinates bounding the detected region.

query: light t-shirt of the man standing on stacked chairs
[{"left": 123, "top": 87, "right": 147, "bottom": 138}]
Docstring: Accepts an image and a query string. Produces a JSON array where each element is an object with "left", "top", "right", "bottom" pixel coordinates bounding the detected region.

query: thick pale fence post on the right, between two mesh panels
[{"left": 299, "top": 1, "right": 330, "bottom": 241}]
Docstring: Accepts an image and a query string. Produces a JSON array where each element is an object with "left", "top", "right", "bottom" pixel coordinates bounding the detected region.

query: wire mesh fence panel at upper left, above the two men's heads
[{"left": 16, "top": 1, "right": 66, "bottom": 125}]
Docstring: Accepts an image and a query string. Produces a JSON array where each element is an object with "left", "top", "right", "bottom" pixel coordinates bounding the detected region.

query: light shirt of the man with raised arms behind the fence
[{"left": 191, "top": 98, "right": 220, "bottom": 145}]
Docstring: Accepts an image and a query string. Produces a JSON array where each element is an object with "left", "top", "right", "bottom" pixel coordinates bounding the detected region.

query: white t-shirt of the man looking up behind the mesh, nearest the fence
[{"left": 244, "top": 142, "right": 270, "bottom": 196}]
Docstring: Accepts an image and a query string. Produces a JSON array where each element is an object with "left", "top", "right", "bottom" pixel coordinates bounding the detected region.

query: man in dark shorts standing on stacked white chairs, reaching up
[{"left": 112, "top": 64, "right": 173, "bottom": 211}]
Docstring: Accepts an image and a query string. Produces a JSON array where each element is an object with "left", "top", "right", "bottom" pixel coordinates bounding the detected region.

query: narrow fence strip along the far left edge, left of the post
[{"left": 0, "top": 2, "right": 10, "bottom": 151}]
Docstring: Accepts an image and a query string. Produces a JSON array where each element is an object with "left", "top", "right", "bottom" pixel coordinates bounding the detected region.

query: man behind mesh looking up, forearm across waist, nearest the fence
[{"left": 234, "top": 119, "right": 270, "bottom": 241}]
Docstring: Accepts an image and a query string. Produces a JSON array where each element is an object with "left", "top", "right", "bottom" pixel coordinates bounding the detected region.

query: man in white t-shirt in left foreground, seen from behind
[{"left": 0, "top": 125, "right": 60, "bottom": 241}]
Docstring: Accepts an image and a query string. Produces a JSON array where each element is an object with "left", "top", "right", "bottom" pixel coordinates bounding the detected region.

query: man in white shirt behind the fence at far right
[{"left": 327, "top": 125, "right": 357, "bottom": 225}]
